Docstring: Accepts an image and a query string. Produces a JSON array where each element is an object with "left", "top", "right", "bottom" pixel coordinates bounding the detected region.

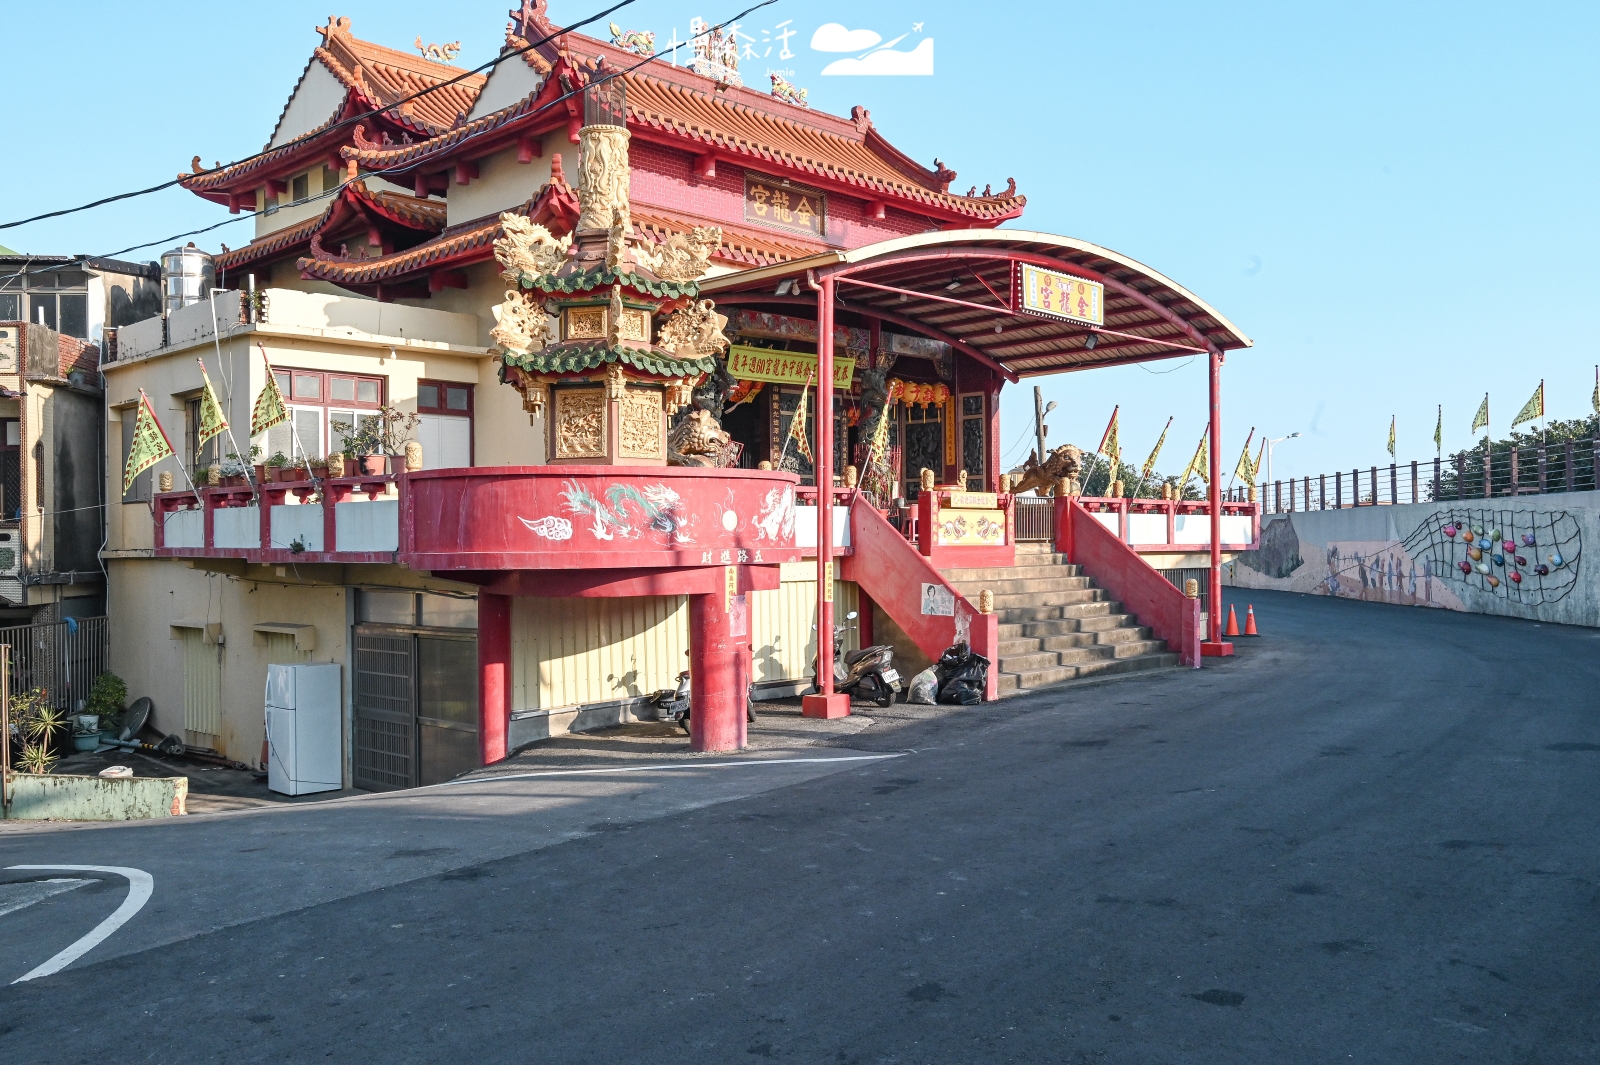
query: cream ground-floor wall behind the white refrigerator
[{"left": 107, "top": 558, "right": 349, "bottom": 764}]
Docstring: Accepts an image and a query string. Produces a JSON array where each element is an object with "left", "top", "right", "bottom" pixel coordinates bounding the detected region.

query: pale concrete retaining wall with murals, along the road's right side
[{"left": 1224, "top": 493, "right": 1600, "bottom": 627}]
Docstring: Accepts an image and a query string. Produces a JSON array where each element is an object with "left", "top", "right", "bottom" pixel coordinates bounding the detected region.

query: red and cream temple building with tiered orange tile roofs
[{"left": 104, "top": 0, "right": 1258, "bottom": 788}]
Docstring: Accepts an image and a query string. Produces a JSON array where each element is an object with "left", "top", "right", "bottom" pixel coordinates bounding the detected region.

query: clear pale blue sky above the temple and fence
[{"left": 0, "top": 0, "right": 1600, "bottom": 477}]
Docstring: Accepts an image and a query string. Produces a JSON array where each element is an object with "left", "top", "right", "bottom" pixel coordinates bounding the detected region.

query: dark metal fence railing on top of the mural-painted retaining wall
[{"left": 1256, "top": 438, "right": 1600, "bottom": 513}]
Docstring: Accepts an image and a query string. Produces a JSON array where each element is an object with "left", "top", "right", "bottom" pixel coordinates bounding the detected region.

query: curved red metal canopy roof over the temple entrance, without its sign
[{"left": 701, "top": 229, "right": 1251, "bottom": 381}]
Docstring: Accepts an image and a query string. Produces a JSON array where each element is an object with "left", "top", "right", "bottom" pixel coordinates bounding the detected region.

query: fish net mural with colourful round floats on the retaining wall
[{"left": 1403, "top": 507, "right": 1582, "bottom": 606}]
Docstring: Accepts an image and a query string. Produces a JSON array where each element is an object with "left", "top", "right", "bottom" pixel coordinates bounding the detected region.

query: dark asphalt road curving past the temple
[{"left": 0, "top": 592, "right": 1600, "bottom": 1065}]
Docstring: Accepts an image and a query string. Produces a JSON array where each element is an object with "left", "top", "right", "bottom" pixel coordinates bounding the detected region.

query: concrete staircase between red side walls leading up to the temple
[{"left": 942, "top": 544, "right": 1179, "bottom": 696}]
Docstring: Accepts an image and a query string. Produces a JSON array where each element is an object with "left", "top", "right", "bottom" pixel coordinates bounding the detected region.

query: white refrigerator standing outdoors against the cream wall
[{"left": 267, "top": 664, "right": 344, "bottom": 795}]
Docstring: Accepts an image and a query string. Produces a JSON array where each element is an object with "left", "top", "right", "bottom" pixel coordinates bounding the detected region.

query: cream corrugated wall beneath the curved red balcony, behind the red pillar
[{"left": 512, "top": 563, "right": 859, "bottom": 713}]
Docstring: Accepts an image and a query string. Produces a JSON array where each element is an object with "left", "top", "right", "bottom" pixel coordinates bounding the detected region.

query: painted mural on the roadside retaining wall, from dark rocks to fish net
[{"left": 1229, "top": 507, "right": 1582, "bottom": 617}]
